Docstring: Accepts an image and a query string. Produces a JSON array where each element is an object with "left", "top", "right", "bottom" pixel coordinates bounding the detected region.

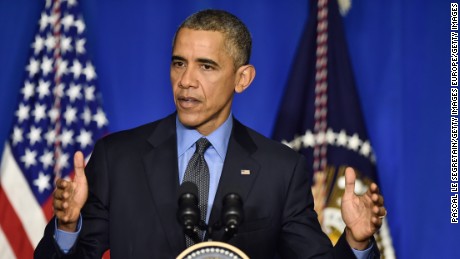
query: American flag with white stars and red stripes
[{"left": 0, "top": 0, "right": 108, "bottom": 258}]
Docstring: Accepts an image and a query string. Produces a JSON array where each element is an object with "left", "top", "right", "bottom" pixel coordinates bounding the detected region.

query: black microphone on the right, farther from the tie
[{"left": 221, "top": 193, "right": 244, "bottom": 240}]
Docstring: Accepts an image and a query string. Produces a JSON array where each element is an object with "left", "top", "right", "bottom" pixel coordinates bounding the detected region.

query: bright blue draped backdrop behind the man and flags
[{"left": 0, "top": 0, "right": 460, "bottom": 259}]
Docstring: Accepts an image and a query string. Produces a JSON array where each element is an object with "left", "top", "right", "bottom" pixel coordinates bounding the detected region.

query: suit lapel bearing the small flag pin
[{"left": 209, "top": 120, "right": 260, "bottom": 240}]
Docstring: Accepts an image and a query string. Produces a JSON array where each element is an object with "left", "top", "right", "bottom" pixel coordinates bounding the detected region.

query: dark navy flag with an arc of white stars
[{"left": 273, "top": 0, "right": 395, "bottom": 259}]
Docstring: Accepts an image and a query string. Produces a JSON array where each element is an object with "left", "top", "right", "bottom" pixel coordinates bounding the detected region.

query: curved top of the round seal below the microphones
[{"left": 176, "top": 241, "right": 249, "bottom": 259}]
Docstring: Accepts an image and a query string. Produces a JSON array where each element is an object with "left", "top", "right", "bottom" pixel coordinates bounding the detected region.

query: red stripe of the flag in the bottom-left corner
[{"left": 0, "top": 186, "right": 34, "bottom": 258}]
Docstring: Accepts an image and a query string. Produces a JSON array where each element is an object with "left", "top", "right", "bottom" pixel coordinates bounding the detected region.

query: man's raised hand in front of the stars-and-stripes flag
[{"left": 53, "top": 151, "right": 88, "bottom": 232}]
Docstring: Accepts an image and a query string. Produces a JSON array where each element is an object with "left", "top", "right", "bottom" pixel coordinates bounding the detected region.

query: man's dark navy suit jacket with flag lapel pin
[{"left": 35, "top": 114, "right": 379, "bottom": 259}]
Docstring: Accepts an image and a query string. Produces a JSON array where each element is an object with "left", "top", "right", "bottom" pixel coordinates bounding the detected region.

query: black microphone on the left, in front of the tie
[{"left": 177, "top": 182, "right": 200, "bottom": 236}]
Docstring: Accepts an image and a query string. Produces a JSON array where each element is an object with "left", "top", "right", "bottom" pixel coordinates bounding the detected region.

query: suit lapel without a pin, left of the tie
[{"left": 143, "top": 114, "right": 185, "bottom": 254}]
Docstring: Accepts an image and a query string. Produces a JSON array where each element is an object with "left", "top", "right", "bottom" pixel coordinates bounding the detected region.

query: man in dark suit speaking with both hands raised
[{"left": 35, "top": 10, "right": 386, "bottom": 258}]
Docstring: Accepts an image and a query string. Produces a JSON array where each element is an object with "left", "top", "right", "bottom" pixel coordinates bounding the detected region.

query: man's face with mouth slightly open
[{"left": 170, "top": 28, "right": 237, "bottom": 135}]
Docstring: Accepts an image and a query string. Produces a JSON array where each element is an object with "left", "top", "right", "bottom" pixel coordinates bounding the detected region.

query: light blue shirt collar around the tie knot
[{"left": 176, "top": 113, "right": 233, "bottom": 161}]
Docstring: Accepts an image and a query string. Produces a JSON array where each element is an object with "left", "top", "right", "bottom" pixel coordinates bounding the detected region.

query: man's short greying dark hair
[{"left": 173, "top": 9, "right": 252, "bottom": 69}]
